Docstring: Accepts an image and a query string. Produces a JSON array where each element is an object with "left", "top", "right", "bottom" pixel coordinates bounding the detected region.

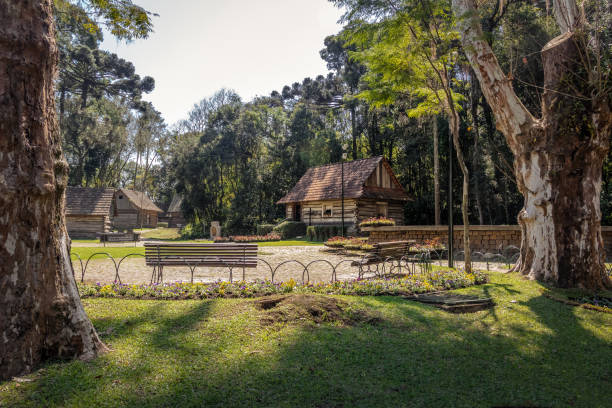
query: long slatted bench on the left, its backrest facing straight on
[{"left": 144, "top": 242, "right": 257, "bottom": 283}]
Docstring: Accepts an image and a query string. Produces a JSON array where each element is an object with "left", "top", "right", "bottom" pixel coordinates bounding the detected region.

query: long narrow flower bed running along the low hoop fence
[{"left": 77, "top": 270, "right": 488, "bottom": 299}]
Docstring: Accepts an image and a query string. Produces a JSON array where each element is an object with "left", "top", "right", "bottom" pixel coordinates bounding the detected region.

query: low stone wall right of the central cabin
[{"left": 362, "top": 225, "right": 612, "bottom": 255}]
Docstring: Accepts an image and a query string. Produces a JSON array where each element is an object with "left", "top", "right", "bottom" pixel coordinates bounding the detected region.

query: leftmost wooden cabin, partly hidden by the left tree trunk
[{"left": 66, "top": 187, "right": 115, "bottom": 239}]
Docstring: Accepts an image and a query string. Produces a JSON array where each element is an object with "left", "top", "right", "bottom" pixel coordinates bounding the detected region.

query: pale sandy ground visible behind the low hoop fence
[{"left": 73, "top": 246, "right": 502, "bottom": 283}]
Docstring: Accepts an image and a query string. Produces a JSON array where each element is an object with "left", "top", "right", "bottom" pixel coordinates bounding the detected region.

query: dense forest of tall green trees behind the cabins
[{"left": 56, "top": 1, "right": 612, "bottom": 232}]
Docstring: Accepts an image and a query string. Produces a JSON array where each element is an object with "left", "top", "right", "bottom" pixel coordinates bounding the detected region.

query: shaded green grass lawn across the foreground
[{"left": 0, "top": 273, "right": 612, "bottom": 408}]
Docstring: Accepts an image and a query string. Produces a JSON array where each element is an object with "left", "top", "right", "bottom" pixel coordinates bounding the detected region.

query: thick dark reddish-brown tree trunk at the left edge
[{"left": 0, "top": 0, "right": 104, "bottom": 379}]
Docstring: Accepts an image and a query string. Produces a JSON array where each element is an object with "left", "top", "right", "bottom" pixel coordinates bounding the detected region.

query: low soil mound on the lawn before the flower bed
[{"left": 254, "top": 295, "right": 380, "bottom": 326}]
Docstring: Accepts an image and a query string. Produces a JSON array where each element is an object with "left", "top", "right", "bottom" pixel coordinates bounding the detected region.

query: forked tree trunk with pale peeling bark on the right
[{"left": 453, "top": 0, "right": 612, "bottom": 289}]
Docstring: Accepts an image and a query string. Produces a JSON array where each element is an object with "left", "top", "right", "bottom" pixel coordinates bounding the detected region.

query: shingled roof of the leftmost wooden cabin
[{"left": 66, "top": 187, "right": 115, "bottom": 215}]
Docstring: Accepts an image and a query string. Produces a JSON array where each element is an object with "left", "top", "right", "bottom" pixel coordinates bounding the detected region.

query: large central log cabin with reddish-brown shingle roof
[{"left": 277, "top": 156, "right": 411, "bottom": 228}]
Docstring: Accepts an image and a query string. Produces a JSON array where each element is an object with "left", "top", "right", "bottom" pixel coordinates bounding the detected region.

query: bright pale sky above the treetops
[{"left": 102, "top": 0, "right": 342, "bottom": 124}]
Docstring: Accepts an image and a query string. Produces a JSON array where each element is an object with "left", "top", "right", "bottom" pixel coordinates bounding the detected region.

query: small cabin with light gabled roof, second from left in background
[{"left": 113, "top": 188, "right": 164, "bottom": 230}]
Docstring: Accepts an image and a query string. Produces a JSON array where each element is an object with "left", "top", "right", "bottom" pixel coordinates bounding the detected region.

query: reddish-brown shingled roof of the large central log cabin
[{"left": 277, "top": 156, "right": 410, "bottom": 204}]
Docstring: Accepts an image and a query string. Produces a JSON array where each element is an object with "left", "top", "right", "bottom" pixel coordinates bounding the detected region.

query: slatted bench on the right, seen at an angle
[{"left": 352, "top": 240, "right": 416, "bottom": 278}]
